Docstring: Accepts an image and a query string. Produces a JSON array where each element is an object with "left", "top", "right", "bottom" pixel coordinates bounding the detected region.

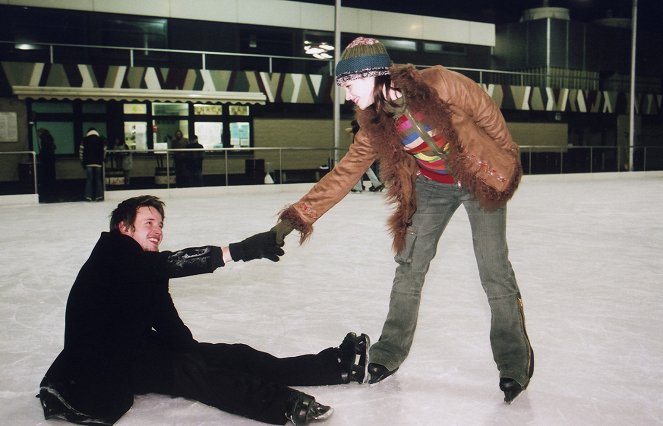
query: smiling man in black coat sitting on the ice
[{"left": 38, "top": 195, "right": 370, "bottom": 425}]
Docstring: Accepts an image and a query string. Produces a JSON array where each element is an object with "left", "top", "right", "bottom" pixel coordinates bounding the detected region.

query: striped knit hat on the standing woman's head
[{"left": 336, "top": 37, "right": 391, "bottom": 86}]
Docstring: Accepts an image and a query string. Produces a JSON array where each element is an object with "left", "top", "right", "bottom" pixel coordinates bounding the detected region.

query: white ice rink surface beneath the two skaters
[{"left": 0, "top": 172, "right": 663, "bottom": 426}]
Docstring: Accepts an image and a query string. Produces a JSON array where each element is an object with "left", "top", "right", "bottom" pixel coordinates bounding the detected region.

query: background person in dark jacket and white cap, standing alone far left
[{"left": 78, "top": 127, "right": 106, "bottom": 201}]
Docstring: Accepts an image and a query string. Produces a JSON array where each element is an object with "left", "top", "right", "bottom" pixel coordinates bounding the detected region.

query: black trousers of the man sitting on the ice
[{"left": 132, "top": 339, "right": 343, "bottom": 424}]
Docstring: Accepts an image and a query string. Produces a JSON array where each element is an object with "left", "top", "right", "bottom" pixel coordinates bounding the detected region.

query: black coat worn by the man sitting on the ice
[{"left": 41, "top": 232, "right": 224, "bottom": 423}]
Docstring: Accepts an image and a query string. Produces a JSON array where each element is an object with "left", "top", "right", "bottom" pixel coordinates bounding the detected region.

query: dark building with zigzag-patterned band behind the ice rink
[{"left": 0, "top": 0, "right": 663, "bottom": 200}]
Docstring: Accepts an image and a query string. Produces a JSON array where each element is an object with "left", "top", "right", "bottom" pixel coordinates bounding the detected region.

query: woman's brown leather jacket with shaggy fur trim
[{"left": 280, "top": 65, "right": 521, "bottom": 252}]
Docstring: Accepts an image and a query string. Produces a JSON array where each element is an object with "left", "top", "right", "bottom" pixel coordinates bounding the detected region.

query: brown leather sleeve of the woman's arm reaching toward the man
[{"left": 280, "top": 136, "right": 377, "bottom": 243}]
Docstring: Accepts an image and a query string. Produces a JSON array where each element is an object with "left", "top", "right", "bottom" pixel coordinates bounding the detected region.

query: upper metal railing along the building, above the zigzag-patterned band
[{"left": 0, "top": 41, "right": 660, "bottom": 93}]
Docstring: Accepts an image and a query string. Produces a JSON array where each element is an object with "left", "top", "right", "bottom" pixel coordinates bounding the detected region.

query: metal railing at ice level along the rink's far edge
[{"left": 0, "top": 146, "right": 663, "bottom": 197}]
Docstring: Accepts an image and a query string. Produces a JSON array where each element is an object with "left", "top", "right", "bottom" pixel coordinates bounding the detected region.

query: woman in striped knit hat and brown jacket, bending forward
[{"left": 273, "top": 37, "right": 534, "bottom": 403}]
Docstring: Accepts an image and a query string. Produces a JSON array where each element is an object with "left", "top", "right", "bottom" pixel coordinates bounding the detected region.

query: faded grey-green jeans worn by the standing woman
[{"left": 370, "top": 177, "right": 532, "bottom": 387}]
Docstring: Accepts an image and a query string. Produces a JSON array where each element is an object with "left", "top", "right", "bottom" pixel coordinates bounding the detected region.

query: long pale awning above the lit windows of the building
[{"left": 12, "top": 86, "right": 267, "bottom": 105}]
